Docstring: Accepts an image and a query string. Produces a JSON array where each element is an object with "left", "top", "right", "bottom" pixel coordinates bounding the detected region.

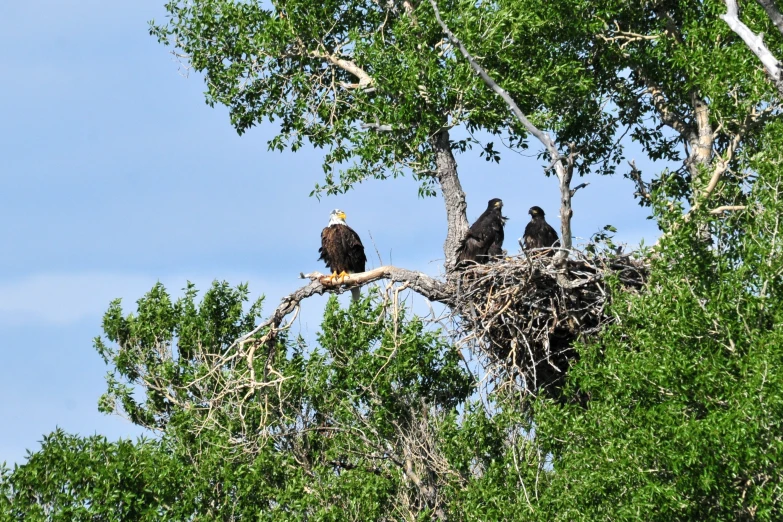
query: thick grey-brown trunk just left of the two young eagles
[{"left": 430, "top": 130, "right": 468, "bottom": 272}]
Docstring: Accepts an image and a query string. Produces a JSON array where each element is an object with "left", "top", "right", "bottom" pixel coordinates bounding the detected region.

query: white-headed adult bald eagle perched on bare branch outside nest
[{"left": 318, "top": 209, "right": 367, "bottom": 301}]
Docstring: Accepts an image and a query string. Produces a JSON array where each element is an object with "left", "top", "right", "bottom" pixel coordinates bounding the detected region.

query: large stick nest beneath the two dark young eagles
[{"left": 452, "top": 251, "right": 648, "bottom": 396}]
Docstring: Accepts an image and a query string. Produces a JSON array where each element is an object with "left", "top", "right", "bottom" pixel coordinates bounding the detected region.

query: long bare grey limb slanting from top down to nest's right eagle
[{"left": 430, "top": 0, "right": 573, "bottom": 262}]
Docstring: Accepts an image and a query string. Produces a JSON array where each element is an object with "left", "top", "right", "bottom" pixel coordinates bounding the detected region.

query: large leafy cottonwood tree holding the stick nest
[{"left": 0, "top": 0, "right": 783, "bottom": 520}]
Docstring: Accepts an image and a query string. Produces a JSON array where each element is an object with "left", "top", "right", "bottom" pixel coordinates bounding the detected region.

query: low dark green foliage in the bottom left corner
[{"left": 0, "top": 430, "right": 181, "bottom": 522}]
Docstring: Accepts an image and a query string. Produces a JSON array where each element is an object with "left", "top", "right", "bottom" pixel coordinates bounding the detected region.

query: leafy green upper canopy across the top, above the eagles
[{"left": 151, "top": 0, "right": 783, "bottom": 204}]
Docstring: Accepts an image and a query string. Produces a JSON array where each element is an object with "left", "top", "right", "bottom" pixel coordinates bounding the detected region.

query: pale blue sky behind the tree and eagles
[{"left": 0, "top": 0, "right": 657, "bottom": 462}]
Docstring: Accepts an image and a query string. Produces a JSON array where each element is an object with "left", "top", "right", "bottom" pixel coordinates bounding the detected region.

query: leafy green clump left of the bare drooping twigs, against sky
[{"left": 94, "top": 281, "right": 263, "bottom": 428}]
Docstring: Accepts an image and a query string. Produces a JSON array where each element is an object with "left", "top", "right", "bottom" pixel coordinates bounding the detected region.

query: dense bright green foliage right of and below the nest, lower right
[{"left": 536, "top": 150, "right": 783, "bottom": 521}]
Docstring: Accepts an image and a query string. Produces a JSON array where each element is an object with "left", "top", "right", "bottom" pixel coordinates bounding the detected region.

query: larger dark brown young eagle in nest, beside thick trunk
[{"left": 457, "top": 198, "right": 508, "bottom": 266}]
